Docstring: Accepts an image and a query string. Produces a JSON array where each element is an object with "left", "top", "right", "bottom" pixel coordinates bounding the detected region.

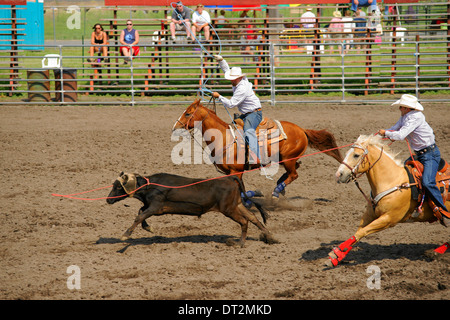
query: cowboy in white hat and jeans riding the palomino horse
[{"left": 378, "top": 94, "right": 450, "bottom": 219}]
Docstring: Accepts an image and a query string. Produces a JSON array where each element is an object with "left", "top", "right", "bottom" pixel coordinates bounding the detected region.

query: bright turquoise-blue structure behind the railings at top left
[{"left": 0, "top": 0, "right": 44, "bottom": 50}]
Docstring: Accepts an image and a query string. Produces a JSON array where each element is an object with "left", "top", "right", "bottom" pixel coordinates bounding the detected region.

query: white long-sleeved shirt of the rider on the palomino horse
[{"left": 385, "top": 111, "right": 435, "bottom": 151}]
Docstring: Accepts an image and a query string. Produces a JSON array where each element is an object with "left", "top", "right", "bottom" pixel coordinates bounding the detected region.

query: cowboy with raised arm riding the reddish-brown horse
[{"left": 212, "top": 55, "right": 262, "bottom": 164}]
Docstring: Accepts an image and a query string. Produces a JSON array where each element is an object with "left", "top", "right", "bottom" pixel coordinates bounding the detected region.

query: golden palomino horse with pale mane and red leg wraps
[{"left": 328, "top": 135, "right": 450, "bottom": 266}]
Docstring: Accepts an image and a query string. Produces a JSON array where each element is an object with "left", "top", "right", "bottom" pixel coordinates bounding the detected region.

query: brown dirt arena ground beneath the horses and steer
[{"left": 0, "top": 104, "right": 450, "bottom": 300}]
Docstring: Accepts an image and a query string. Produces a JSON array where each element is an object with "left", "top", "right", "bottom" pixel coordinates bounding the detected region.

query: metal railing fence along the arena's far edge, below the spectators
[{"left": 0, "top": 35, "right": 450, "bottom": 105}]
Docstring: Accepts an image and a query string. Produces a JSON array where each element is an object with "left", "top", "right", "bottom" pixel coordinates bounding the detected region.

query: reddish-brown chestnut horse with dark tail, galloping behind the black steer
[{"left": 173, "top": 99, "right": 342, "bottom": 197}]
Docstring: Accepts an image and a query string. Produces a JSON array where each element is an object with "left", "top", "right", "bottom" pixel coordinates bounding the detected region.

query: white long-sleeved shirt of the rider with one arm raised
[{"left": 219, "top": 60, "right": 261, "bottom": 113}]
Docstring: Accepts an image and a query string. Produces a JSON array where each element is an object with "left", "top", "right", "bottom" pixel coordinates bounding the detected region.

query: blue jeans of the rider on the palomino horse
[{"left": 417, "top": 145, "right": 448, "bottom": 211}]
